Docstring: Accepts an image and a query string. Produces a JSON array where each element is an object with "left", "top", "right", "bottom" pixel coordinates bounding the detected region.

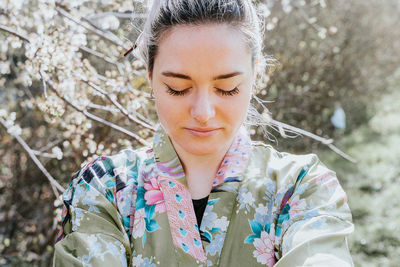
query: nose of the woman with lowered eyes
[{"left": 190, "top": 92, "right": 215, "bottom": 124}]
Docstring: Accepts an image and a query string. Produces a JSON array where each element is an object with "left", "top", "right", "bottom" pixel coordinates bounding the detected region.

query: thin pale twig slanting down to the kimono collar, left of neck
[{"left": 48, "top": 81, "right": 149, "bottom": 146}]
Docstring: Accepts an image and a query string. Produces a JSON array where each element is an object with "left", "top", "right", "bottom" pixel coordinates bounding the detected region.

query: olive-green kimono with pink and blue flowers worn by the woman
[{"left": 53, "top": 125, "right": 354, "bottom": 267}]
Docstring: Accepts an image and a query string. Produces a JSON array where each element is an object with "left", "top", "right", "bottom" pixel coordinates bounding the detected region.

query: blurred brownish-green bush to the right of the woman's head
[{"left": 252, "top": 0, "right": 400, "bottom": 153}]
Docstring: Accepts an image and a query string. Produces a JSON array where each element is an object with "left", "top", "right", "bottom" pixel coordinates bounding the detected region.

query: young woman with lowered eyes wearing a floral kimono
[{"left": 54, "top": 0, "right": 354, "bottom": 267}]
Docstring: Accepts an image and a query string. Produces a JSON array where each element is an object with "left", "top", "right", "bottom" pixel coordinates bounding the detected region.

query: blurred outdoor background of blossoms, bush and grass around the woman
[{"left": 0, "top": 0, "right": 400, "bottom": 267}]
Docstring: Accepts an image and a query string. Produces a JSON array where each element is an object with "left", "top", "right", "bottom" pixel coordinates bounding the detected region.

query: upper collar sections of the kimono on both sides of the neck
[{"left": 153, "top": 124, "right": 251, "bottom": 188}]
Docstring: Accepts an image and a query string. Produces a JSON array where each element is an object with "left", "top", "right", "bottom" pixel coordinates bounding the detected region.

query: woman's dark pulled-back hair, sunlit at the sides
[{"left": 134, "top": 0, "right": 267, "bottom": 87}]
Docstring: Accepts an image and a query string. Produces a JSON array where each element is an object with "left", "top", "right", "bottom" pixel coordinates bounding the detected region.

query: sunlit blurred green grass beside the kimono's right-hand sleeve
[{"left": 322, "top": 69, "right": 400, "bottom": 267}]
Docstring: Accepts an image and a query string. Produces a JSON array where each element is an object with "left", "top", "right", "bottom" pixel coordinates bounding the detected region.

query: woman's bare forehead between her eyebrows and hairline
[{"left": 154, "top": 24, "right": 251, "bottom": 73}]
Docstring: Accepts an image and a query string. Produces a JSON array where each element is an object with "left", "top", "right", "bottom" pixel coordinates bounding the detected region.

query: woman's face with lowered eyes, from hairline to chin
[{"left": 148, "top": 24, "right": 254, "bottom": 155}]
